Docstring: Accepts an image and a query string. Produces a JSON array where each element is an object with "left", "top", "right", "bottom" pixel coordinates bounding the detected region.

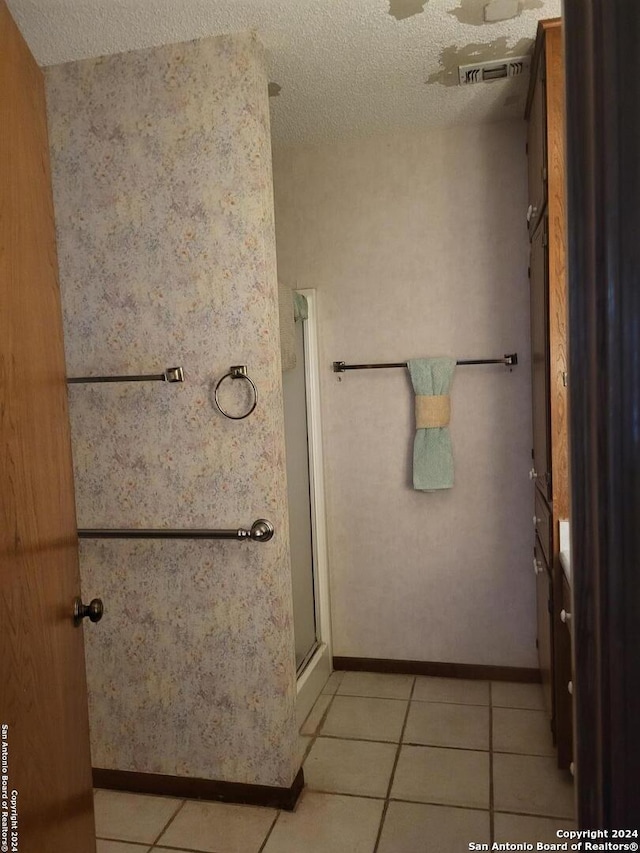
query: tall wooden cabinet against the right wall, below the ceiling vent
[{"left": 526, "top": 19, "right": 572, "bottom": 768}]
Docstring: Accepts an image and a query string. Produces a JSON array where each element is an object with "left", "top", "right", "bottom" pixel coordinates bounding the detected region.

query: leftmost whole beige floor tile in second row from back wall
[{"left": 320, "top": 696, "right": 408, "bottom": 743}]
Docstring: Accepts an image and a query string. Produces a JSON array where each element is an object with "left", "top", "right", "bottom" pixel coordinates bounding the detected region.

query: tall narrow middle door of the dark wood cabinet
[{"left": 529, "top": 213, "right": 551, "bottom": 500}]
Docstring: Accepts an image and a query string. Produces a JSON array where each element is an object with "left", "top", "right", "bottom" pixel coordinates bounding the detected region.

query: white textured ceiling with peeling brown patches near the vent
[{"left": 8, "top": 0, "right": 561, "bottom": 145}]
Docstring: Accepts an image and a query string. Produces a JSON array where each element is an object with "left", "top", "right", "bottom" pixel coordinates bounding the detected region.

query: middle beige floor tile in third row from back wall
[{"left": 391, "top": 746, "right": 489, "bottom": 809}]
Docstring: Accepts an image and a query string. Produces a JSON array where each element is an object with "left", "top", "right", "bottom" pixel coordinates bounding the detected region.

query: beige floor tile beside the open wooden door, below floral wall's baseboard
[{"left": 94, "top": 790, "right": 183, "bottom": 844}]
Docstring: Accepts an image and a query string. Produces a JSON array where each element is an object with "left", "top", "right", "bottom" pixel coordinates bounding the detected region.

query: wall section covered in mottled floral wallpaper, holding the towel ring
[{"left": 46, "top": 35, "right": 297, "bottom": 785}]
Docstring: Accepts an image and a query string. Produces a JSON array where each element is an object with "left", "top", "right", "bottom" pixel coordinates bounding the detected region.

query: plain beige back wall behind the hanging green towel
[{"left": 274, "top": 122, "right": 536, "bottom": 666}]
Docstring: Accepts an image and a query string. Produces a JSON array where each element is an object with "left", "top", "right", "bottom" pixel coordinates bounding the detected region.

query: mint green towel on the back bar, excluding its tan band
[{"left": 407, "top": 357, "right": 456, "bottom": 492}]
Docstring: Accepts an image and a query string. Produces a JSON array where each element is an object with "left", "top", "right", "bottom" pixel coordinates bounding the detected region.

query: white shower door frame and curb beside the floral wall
[{"left": 296, "top": 288, "right": 332, "bottom": 725}]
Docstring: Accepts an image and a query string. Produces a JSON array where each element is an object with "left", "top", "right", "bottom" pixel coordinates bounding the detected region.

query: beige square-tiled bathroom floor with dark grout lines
[{"left": 95, "top": 672, "right": 574, "bottom": 853}]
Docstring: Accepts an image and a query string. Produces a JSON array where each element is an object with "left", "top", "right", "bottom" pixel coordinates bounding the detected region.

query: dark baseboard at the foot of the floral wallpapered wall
[{"left": 93, "top": 767, "right": 304, "bottom": 811}]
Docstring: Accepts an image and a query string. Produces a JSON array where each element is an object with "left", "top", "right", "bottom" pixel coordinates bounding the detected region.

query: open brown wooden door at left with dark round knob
[{"left": 0, "top": 0, "right": 95, "bottom": 853}]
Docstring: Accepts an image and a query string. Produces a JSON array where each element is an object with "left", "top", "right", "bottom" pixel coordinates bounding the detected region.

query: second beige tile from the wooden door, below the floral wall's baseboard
[{"left": 158, "top": 802, "right": 277, "bottom": 853}]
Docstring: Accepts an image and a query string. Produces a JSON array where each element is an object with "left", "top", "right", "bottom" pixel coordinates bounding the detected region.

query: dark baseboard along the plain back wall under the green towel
[{"left": 333, "top": 657, "right": 541, "bottom": 684}]
